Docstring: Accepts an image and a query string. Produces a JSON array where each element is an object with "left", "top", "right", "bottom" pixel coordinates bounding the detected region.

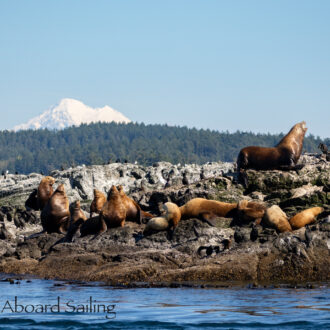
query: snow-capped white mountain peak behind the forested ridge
[{"left": 14, "top": 98, "right": 131, "bottom": 131}]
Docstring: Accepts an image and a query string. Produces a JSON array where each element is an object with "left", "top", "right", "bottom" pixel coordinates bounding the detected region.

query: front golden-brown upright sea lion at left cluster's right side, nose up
[{"left": 100, "top": 186, "right": 126, "bottom": 234}]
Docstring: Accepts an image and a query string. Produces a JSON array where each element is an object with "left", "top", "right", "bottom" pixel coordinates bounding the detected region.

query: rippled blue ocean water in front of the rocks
[{"left": 0, "top": 275, "right": 330, "bottom": 330}]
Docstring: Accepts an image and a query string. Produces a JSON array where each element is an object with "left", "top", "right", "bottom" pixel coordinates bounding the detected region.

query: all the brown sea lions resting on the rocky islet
[{"left": 26, "top": 121, "right": 323, "bottom": 241}]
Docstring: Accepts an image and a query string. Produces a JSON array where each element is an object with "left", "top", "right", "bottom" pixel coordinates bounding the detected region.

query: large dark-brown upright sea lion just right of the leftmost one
[{"left": 41, "top": 184, "right": 70, "bottom": 233}]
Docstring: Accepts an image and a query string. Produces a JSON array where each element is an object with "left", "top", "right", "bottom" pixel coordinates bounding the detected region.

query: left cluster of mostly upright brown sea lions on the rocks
[{"left": 25, "top": 176, "right": 153, "bottom": 241}]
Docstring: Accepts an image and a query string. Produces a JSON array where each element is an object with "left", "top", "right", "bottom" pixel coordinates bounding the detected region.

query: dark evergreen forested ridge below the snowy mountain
[{"left": 0, "top": 123, "right": 330, "bottom": 174}]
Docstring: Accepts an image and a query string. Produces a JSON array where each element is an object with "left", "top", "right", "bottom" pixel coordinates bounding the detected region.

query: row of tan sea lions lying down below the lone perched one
[{"left": 144, "top": 198, "right": 324, "bottom": 234}]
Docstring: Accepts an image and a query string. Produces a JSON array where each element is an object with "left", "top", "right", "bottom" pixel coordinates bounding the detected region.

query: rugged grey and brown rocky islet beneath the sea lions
[{"left": 0, "top": 155, "right": 330, "bottom": 286}]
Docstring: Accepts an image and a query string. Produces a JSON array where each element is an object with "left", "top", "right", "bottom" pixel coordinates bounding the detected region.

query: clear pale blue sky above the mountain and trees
[{"left": 0, "top": 0, "right": 330, "bottom": 137}]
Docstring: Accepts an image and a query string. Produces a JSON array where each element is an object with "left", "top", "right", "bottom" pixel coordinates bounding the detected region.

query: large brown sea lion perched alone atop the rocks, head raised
[{"left": 237, "top": 121, "right": 307, "bottom": 183}]
